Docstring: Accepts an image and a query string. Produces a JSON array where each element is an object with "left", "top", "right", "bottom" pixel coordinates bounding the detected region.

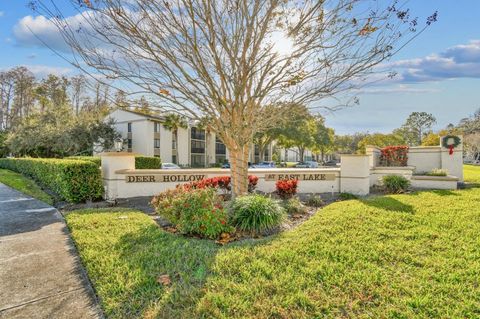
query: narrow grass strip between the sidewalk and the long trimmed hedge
[{"left": 0, "top": 169, "right": 53, "bottom": 205}]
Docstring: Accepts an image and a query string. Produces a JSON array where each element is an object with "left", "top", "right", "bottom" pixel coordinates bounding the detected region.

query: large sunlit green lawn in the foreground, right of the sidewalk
[{"left": 66, "top": 167, "right": 480, "bottom": 318}]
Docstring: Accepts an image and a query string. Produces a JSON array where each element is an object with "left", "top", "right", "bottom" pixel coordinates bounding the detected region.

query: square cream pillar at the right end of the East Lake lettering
[{"left": 340, "top": 154, "right": 370, "bottom": 195}]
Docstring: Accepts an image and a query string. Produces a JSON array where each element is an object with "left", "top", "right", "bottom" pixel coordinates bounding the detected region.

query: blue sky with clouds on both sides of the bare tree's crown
[{"left": 0, "top": 0, "right": 480, "bottom": 134}]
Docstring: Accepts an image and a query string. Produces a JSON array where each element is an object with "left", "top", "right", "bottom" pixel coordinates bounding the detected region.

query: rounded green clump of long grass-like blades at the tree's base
[{"left": 230, "top": 194, "right": 285, "bottom": 233}]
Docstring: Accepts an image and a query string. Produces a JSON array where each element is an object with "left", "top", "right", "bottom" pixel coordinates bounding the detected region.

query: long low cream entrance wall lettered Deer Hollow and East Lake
[{"left": 101, "top": 138, "right": 463, "bottom": 199}]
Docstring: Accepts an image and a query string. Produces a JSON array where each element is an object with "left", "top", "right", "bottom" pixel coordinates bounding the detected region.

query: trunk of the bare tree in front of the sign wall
[{"left": 228, "top": 145, "right": 249, "bottom": 198}]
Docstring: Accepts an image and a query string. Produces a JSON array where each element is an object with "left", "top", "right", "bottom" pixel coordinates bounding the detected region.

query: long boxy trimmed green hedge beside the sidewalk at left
[{"left": 0, "top": 158, "right": 103, "bottom": 203}]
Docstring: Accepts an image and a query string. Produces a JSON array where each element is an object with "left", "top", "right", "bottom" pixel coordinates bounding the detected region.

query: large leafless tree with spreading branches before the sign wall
[{"left": 32, "top": 0, "right": 436, "bottom": 195}]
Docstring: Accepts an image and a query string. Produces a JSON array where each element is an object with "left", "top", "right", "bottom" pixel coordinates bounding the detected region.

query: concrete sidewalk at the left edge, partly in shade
[{"left": 0, "top": 183, "right": 103, "bottom": 319}]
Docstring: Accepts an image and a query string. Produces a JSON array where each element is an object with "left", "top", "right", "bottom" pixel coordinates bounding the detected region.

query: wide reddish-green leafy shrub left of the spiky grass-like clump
[{"left": 151, "top": 187, "right": 233, "bottom": 239}]
